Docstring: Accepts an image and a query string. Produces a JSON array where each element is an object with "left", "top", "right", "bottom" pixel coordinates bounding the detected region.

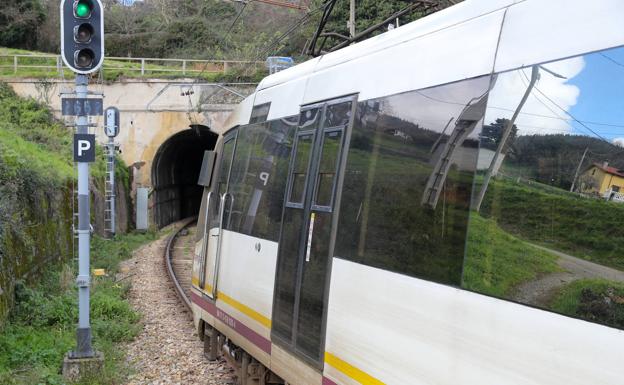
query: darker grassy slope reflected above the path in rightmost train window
[{"left": 482, "top": 179, "right": 624, "bottom": 270}]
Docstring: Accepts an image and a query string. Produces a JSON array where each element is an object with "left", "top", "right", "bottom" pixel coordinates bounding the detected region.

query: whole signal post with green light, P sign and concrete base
[{"left": 60, "top": 0, "right": 104, "bottom": 380}]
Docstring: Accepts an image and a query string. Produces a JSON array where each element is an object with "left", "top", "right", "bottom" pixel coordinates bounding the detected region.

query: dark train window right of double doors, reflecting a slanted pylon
[{"left": 335, "top": 76, "right": 490, "bottom": 285}]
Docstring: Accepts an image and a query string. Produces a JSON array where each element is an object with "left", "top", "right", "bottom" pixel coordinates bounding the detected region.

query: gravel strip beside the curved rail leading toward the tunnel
[{"left": 122, "top": 225, "right": 234, "bottom": 385}]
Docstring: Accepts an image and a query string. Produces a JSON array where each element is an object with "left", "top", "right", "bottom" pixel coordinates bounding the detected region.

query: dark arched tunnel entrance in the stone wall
[{"left": 152, "top": 125, "right": 219, "bottom": 228}]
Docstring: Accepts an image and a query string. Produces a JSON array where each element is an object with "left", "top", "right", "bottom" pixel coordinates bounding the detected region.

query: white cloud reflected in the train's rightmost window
[{"left": 485, "top": 57, "right": 585, "bottom": 135}]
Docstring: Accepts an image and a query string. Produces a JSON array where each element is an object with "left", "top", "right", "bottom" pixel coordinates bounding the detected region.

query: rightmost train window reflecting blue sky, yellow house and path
[{"left": 462, "top": 43, "right": 624, "bottom": 328}]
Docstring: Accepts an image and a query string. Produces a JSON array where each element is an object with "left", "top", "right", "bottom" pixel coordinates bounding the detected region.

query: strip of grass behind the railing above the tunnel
[{"left": 0, "top": 47, "right": 267, "bottom": 83}]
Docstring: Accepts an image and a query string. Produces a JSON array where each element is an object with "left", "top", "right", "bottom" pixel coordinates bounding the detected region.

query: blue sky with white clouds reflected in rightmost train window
[{"left": 485, "top": 44, "right": 624, "bottom": 144}]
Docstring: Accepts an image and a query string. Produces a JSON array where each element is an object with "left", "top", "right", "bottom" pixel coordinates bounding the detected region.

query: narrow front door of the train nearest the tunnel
[{"left": 200, "top": 130, "right": 238, "bottom": 299}]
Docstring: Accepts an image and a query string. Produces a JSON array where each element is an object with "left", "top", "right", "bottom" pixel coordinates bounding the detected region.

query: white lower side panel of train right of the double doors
[{"left": 324, "top": 258, "right": 624, "bottom": 385}]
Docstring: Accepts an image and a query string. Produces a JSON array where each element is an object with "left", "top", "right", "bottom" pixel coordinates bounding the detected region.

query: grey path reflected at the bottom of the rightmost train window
[{"left": 512, "top": 244, "right": 624, "bottom": 306}]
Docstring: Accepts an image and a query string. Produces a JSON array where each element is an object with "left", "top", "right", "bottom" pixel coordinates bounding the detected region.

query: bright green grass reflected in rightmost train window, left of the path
[{"left": 462, "top": 212, "right": 559, "bottom": 297}]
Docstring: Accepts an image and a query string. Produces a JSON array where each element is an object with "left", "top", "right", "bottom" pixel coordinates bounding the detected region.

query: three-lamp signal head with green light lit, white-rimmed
[{"left": 61, "top": 0, "right": 104, "bottom": 75}]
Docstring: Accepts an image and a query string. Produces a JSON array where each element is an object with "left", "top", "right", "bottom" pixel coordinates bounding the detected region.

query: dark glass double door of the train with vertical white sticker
[{"left": 272, "top": 97, "right": 355, "bottom": 368}]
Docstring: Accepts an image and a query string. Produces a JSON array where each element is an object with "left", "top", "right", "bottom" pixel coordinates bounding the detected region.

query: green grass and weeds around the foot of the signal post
[{"left": 0, "top": 232, "right": 158, "bottom": 385}]
